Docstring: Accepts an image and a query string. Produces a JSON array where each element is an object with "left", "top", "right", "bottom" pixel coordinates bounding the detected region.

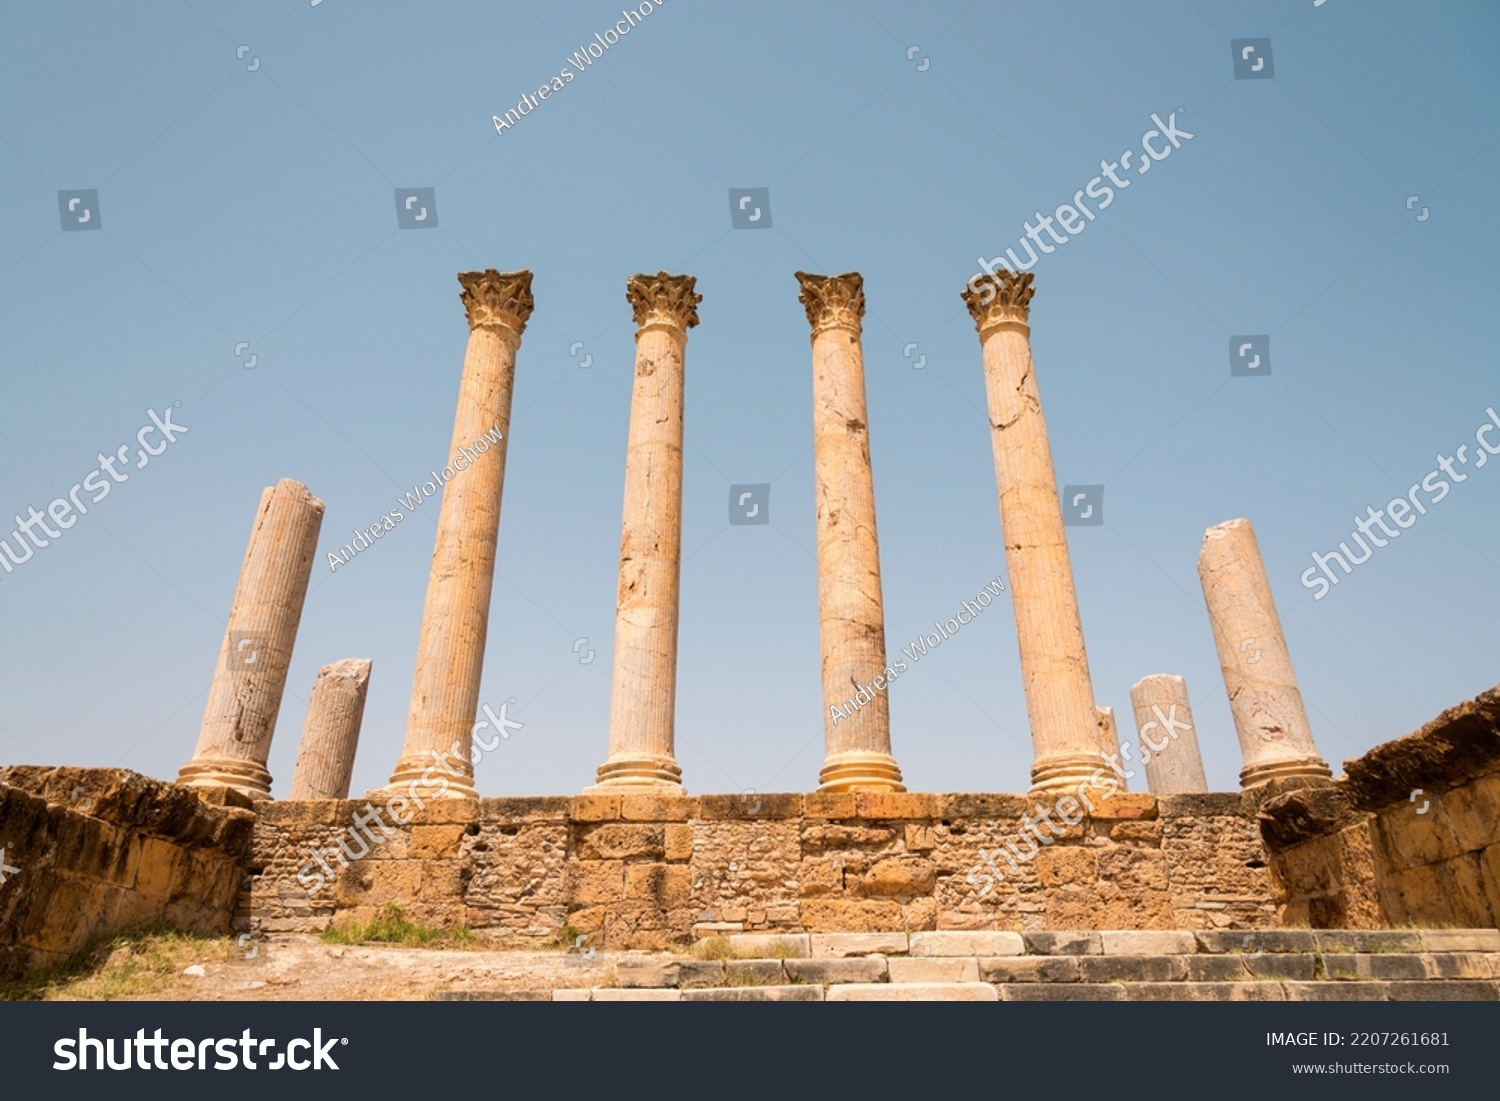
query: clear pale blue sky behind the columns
[{"left": 0, "top": 0, "right": 1500, "bottom": 795}]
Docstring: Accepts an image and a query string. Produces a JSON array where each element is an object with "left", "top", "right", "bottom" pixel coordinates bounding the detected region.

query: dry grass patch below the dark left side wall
[{"left": 0, "top": 929, "right": 220, "bottom": 1002}]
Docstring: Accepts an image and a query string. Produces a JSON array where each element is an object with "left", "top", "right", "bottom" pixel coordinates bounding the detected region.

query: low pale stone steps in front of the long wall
[{"left": 435, "top": 929, "right": 1500, "bottom": 1002}]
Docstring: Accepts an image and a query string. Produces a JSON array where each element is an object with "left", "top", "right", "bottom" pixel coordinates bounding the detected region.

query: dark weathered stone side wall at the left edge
[{"left": 0, "top": 767, "right": 254, "bottom": 978}]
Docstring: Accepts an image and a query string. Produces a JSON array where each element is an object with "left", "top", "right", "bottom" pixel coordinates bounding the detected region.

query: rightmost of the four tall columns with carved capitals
[{"left": 963, "top": 269, "right": 1107, "bottom": 792}]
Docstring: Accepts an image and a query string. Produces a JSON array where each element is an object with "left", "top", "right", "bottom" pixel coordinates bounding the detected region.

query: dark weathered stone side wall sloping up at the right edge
[{"left": 1260, "top": 687, "right": 1500, "bottom": 929}]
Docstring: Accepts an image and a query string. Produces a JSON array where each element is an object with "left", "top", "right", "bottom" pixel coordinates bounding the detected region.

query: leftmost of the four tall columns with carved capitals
[{"left": 390, "top": 269, "right": 533, "bottom": 798}]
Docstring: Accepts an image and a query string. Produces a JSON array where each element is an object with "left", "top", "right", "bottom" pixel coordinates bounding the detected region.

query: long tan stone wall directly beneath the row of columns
[{"left": 246, "top": 794, "right": 1277, "bottom": 948}]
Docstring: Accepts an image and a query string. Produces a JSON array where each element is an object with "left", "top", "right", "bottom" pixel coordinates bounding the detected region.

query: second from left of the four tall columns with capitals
[{"left": 588, "top": 272, "right": 704, "bottom": 795}]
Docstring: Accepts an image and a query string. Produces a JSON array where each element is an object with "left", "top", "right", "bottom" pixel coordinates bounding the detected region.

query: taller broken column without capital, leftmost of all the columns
[{"left": 177, "top": 479, "right": 323, "bottom": 800}]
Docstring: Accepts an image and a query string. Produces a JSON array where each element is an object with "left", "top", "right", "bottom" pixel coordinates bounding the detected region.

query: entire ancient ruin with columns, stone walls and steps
[{"left": 0, "top": 270, "right": 1500, "bottom": 1001}]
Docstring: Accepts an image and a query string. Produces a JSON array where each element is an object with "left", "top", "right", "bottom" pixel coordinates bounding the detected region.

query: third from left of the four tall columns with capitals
[{"left": 797, "top": 272, "right": 906, "bottom": 792}]
